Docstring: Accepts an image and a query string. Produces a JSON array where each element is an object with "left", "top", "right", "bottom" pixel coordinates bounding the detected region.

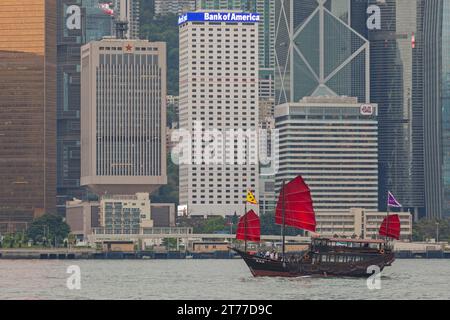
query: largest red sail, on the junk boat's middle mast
[{"left": 275, "top": 176, "right": 316, "bottom": 232}]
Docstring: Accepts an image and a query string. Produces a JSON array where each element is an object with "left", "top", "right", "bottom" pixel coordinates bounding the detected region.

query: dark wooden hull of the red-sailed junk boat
[{"left": 234, "top": 249, "right": 395, "bottom": 278}]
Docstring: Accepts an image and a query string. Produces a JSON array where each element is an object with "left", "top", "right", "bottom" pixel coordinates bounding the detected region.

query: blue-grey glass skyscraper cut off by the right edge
[{"left": 423, "top": 0, "right": 450, "bottom": 219}]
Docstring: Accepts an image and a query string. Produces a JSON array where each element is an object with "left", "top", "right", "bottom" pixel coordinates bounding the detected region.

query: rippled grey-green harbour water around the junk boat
[{"left": 0, "top": 260, "right": 450, "bottom": 300}]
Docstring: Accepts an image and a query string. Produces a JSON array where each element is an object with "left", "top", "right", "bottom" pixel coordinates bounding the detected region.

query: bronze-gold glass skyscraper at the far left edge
[{"left": 0, "top": 0, "right": 56, "bottom": 232}]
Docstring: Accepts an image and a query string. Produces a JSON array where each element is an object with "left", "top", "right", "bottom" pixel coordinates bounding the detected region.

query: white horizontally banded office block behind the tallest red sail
[{"left": 275, "top": 97, "right": 378, "bottom": 214}]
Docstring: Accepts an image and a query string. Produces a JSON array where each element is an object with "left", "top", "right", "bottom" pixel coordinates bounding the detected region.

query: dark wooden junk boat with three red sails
[{"left": 233, "top": 176, "right": 400, "bottom": 277}]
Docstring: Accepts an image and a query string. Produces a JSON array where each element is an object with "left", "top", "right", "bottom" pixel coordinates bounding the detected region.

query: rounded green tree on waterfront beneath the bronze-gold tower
[{"left": 27, "top": 214, "right": 70, "bottom": 245}]
